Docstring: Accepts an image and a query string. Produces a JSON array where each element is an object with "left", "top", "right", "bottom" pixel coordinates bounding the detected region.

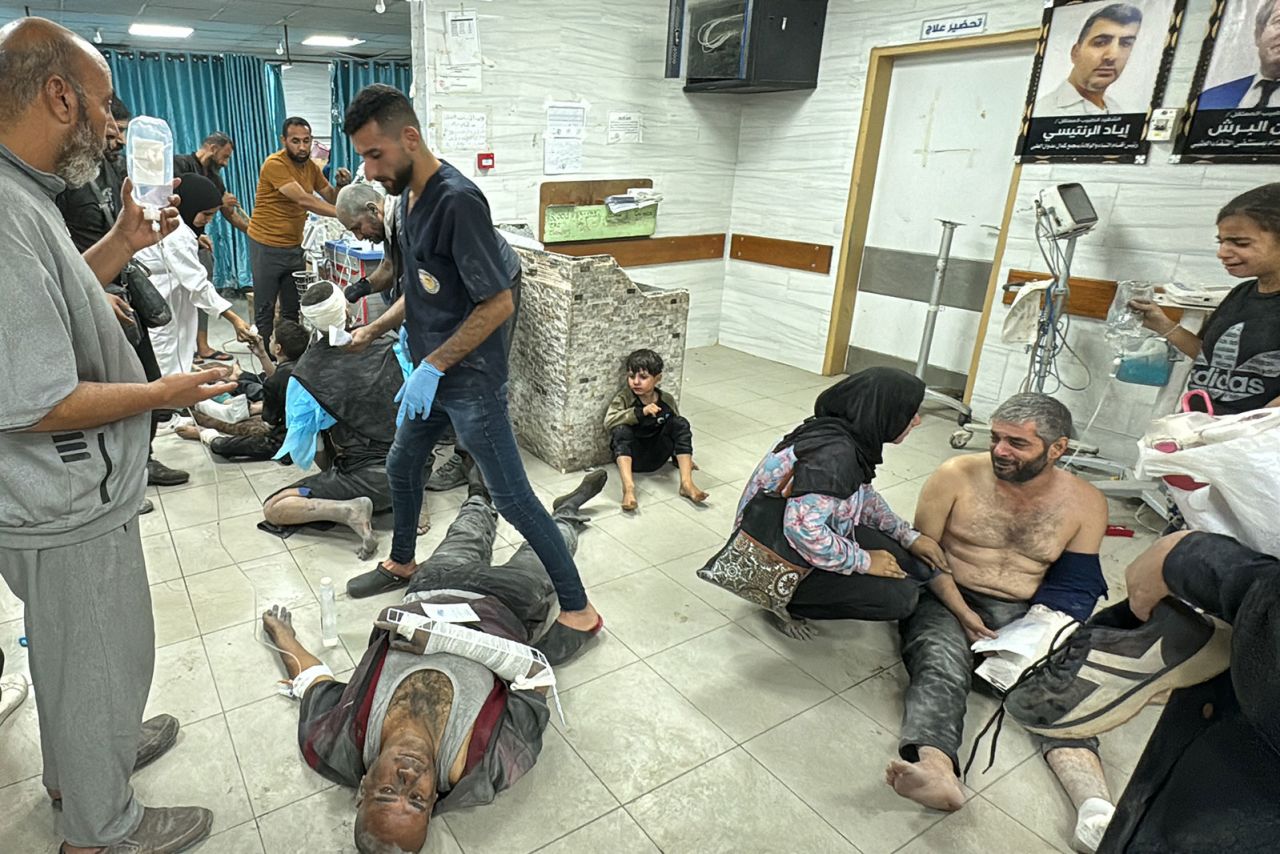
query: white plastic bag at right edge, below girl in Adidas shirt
[{"left": 1138, "top": 408, "right": 1280, "bottom": 557}]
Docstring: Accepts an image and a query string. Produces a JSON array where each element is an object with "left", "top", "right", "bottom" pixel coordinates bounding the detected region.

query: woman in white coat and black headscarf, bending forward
[{"left": 136, "top": 173, "right": 253, "bottom": 376}]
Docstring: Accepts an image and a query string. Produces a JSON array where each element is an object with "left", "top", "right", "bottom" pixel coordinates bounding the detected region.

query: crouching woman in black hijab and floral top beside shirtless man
[{"left": 739, "top": 367, "right": 946, "bottom": 638}]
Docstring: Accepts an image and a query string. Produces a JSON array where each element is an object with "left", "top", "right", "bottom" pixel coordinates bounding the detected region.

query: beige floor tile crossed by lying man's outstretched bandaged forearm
[{"left": 204, "top": 604, "right": 355, "bottom": 709}]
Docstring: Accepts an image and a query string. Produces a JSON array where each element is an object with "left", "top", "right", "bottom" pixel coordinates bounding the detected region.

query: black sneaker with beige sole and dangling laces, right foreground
[{"left": 1005, "top": 598, "right": 1231, "bottom": 739}]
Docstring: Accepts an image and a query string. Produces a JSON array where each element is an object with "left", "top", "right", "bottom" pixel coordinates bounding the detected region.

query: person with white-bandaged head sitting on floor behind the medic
[{"left": 262, "top": 282, "right": 407, "bottom": 558}]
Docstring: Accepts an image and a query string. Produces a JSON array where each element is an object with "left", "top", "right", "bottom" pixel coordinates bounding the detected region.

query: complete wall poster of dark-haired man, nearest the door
[{"left": 1018, "top": 0, "right": 1187, "bottom": 163}]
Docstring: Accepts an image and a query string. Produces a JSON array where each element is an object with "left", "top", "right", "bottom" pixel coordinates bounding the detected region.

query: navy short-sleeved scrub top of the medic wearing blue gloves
[{"left": 397, "top": 163, "right": 518, "bottom": 398}]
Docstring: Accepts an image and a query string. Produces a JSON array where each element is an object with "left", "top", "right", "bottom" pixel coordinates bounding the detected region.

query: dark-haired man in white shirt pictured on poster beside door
[{"left": 1032, "top": 3, "right": 1142, "bottom": 118}]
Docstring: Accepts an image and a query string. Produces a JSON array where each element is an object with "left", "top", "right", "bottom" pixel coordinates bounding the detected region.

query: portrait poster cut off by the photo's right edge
[{"left": 1172, "top": 0, "right": 1280, "bottom": 163}]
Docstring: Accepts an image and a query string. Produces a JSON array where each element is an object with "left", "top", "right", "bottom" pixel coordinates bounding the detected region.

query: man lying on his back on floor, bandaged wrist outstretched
[{"left": 262, "top": 466, "right": 607, "bottom": 854}]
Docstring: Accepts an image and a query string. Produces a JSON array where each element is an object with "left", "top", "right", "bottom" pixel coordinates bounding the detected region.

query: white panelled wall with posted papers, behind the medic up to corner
[{"left": 415, "top": 0, "right": 741, "bottom": 346}]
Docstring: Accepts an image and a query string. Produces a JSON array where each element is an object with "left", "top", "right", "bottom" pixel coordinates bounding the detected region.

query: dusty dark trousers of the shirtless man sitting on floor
[{"left": 897, "top": 588, "right": 1098, "bottom": 776}]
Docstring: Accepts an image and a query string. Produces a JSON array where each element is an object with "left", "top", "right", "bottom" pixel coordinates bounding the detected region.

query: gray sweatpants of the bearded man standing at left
[{"left": 0, "top": 519, "right": 155, "bottom": 848}]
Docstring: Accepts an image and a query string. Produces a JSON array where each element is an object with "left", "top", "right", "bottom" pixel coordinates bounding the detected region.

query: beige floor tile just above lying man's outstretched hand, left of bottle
[{"left": 187, "top": 553, "right": 316, "bottom": 632}]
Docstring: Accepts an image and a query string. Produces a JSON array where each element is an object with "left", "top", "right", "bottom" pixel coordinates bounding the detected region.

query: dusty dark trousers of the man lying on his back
[{"left": 406, "top": 498, "right": 577, "bottom": 643}]
